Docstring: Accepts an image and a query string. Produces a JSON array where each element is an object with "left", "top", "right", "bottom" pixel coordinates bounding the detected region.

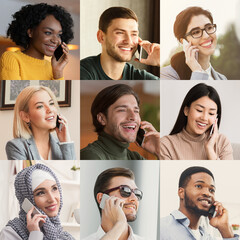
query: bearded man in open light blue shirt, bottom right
[{"left": 160, "top": 166, "right": 239, "bottom": 240}]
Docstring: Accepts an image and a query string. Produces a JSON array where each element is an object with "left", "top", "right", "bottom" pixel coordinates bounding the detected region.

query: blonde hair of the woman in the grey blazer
[{"left": 13, "top": 86, "right": 59, "bottom": 139}]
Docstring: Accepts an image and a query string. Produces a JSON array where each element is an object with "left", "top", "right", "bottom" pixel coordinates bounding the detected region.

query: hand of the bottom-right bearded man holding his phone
[{"left": 209, "top": 201, "right": 234, "bottom": 238}]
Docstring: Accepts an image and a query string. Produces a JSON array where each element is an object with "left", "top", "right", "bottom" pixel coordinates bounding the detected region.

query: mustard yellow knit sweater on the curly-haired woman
[{"left": 0, "top": 51, "right": 64, "bottom": 80}]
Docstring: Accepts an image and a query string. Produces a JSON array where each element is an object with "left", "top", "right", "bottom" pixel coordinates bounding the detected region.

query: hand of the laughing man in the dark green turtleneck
[{"left": 138, "top": 121, "right": 160, "bottom": 159}]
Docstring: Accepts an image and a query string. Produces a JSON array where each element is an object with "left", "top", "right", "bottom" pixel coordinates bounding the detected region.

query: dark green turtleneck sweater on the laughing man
[{"left": 80, "top": 132, "right": 145, "bottom": 160}]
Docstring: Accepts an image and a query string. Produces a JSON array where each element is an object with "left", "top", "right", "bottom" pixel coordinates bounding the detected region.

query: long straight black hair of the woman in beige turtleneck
[{"left": 170, "top": 83, "right": 222, "bottom": 135}]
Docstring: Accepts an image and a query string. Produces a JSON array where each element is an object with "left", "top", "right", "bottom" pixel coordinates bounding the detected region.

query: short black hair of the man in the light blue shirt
[{"left": 178, "top": 166, "right": 214, "bottom": 188}]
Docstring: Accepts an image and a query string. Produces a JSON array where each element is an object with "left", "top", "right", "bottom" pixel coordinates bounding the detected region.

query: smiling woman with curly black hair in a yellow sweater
[{"left": 0, "top": 3, "right": 73, "bottom": 80}]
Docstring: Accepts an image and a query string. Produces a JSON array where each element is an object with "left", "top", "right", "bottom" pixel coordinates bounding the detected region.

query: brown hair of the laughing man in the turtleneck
[{"left": 91, "top": 84, "right": 140, "bottom": 134}]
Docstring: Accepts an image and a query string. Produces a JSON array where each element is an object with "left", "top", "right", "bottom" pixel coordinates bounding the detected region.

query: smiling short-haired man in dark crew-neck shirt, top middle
[{"left": 80, "top": 7, "right": 160, "bottom": 80}]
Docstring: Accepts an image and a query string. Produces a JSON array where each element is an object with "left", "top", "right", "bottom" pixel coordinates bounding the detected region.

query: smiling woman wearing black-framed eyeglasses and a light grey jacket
[{"left": 160, "top": 7, "right": 227, "bottom": 80}]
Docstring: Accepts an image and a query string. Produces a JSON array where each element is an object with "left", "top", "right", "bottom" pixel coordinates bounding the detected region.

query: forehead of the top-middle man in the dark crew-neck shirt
[{"left": 107, "top": 18, "right": 138, "bottom": 31}]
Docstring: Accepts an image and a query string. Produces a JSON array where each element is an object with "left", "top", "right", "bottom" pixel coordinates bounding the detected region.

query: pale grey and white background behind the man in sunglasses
[{"left": 80, "top": 160, "right": 159, "bottom": 239}]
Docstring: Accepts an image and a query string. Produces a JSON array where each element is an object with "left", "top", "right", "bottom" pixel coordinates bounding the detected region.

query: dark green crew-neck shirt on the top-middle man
[{"left": 80, "top": 54, "right": 159, "bottom": 80}]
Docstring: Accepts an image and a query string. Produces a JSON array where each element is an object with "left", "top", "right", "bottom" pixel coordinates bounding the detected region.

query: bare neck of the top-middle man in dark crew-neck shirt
[{"left": 100, "top": 51, "right": 125, "bottom": 80}]
